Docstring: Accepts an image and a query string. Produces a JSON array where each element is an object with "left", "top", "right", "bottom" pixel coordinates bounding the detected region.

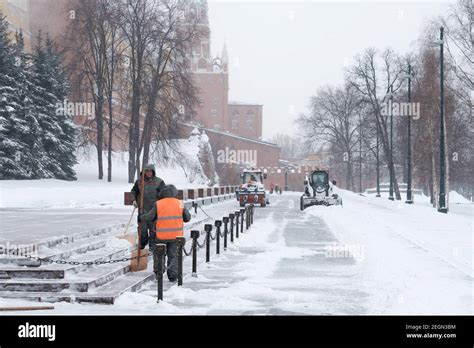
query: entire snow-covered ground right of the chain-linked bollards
[{"left": 0, "top": 192, "right": 474, "bottom": 315}]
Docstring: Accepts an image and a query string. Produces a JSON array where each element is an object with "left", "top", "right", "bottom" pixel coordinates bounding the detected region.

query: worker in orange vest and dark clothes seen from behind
[{"left": 140, "top": 185, "right": 191, "bottom": 282}]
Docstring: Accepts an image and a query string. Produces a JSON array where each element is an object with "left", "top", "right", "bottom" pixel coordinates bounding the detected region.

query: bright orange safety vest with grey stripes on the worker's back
[{"left": 156, "top": 198, "right": 184, "bottom": 240}]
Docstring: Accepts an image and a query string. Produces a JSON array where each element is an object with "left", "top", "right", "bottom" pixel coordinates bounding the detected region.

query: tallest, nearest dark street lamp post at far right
[{"left": 432, "top": 27, "right": 448, "bottom": 213}]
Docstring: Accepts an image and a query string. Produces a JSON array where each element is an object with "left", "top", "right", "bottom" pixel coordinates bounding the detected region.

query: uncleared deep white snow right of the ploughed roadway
[{"left": 305, "top": 189, "right": 474, "bottom": 314}]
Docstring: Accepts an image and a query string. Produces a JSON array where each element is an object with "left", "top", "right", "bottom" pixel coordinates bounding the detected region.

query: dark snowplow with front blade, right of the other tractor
[{"left": 300, "top": 170, "right": 342, "bottom": 210}]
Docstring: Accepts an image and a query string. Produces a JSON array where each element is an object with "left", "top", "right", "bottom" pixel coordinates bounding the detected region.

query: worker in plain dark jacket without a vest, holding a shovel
[{"left": 132, "top": 164, "right": 165, "bottom": 244}]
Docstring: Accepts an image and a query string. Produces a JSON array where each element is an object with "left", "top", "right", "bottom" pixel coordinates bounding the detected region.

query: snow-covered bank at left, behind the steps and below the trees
[{"left": 0, "top": 129, "right": 218, "bottom": 209}]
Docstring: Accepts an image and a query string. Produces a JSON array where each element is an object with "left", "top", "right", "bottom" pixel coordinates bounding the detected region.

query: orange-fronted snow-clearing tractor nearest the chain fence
[{"left": 235, "top": 169, "right": 269, "bottom": 207}]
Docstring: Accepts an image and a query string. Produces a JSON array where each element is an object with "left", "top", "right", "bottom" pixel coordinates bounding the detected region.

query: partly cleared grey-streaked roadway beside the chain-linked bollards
[{"left": 133, "top": 194, "right": 368, "bottom": 315}]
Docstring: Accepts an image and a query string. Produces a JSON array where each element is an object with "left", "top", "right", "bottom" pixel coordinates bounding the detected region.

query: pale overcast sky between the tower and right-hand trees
[{"left": 208, "top": 0, "right": 450, "bottom": 139}]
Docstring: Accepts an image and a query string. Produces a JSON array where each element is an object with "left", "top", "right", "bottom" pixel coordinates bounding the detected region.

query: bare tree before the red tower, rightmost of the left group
[{"left": 139, "top": 0, "right": 199, "bottom": 166}]
